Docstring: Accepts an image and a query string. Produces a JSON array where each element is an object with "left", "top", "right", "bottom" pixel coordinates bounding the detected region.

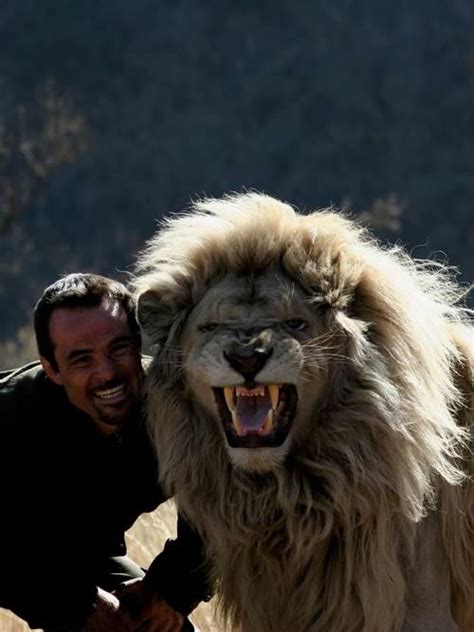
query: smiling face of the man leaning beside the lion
[{"left": 41, "top": 301, "right": 143, "bottom": 434}]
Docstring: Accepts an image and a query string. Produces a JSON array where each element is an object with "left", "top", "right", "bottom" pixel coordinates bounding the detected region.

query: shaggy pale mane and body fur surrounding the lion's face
[{"left": 135, "top": 193, "right": 474, "bottom": 632}]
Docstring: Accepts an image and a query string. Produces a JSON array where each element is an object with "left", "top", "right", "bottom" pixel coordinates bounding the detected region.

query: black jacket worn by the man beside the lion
[{"left": 0, "top": 363, "right": 208, "bottom": 627}]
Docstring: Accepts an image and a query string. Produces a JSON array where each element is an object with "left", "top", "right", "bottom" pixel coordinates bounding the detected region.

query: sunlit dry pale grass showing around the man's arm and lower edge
[{"left": 0, "top": 502, "right": 222, "bottom": 632}]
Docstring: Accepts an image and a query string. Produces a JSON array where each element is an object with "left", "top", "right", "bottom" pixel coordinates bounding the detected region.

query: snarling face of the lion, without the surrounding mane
[{"left": 182, "top": 271, "right": 326, "bottom": 470}]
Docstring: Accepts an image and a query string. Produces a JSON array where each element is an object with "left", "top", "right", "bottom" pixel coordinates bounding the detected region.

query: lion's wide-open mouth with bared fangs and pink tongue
[{"left": 214, "top": 384, "right": 298, "bottom": 448}]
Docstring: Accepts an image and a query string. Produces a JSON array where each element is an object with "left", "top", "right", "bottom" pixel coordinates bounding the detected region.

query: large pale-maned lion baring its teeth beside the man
[{"left": 134, "top": 192, "right": 474, "bottom": 632}]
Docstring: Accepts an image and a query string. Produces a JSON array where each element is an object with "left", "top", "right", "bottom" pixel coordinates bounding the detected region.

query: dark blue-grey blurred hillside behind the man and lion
[{"left": 0, "top": 0, "right": 474, "bottom": 632}]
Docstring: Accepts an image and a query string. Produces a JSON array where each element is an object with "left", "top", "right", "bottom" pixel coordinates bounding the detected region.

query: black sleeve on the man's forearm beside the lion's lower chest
[{"left": 144, "top": 516, "right": 213, "bottom": 616}]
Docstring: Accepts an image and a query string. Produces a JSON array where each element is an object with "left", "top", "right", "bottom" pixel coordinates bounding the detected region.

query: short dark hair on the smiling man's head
[{"left": 34, "top": 273, "right": 141, "bottom": 369}]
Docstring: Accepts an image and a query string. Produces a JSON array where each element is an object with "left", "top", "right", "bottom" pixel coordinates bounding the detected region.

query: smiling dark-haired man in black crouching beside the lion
[{"left": 0, "top": 274, "right": 208, "bottom": 632}]
